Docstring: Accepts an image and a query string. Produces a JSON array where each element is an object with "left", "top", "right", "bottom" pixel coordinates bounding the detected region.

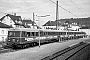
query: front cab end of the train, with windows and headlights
[{"left": 6, "top": 30, "right": 25, "bottom": 47}]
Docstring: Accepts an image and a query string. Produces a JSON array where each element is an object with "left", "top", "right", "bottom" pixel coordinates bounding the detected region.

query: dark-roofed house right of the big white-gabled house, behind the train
[{"left": 22, "top": 19, "right": 38, "bottom": 29}]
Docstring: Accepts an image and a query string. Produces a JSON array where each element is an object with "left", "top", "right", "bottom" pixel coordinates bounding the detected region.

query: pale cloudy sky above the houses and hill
[{"left": 0, "top": 0, "right": 90, "bottom": 25}]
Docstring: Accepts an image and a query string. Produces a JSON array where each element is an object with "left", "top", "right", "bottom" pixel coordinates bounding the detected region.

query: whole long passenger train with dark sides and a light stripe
[{"left": 6, "top": 28, "right": 86, "bottom": 48}]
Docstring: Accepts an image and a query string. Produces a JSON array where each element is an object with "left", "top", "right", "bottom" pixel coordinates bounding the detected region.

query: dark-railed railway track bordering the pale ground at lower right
[{"left": 41, "top": 42, "right": 89, "bottom": 60}]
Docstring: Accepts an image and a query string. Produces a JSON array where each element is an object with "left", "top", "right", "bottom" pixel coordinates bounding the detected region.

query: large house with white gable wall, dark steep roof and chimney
[{"left": 0, "top": 13, "right": 25, "bottom": 28}]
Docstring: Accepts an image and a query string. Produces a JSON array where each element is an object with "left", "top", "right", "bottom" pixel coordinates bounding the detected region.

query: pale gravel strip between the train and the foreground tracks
[{"left": 0, "top": 38, "right": 90, "bottom": 60}]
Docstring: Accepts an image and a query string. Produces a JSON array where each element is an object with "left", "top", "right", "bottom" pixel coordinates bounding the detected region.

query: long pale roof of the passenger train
[{"left": 9, "top": 28, "right": 84, "bottom": 32}]
